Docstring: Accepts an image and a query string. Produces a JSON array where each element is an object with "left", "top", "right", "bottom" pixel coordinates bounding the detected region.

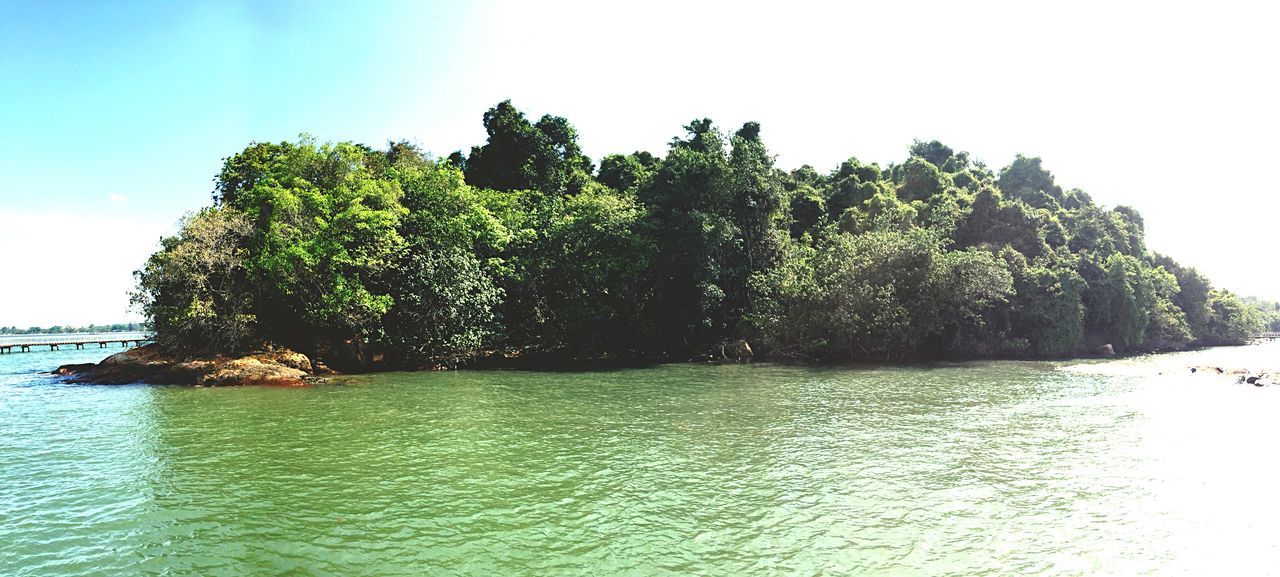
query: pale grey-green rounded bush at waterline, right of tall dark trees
[{"left": 771, "top": 229, "right": 1012, "bottom": 360}]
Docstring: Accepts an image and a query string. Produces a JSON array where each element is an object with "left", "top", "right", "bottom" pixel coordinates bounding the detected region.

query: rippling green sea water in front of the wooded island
[{"left": 0, "top": 345, "right": 1280, "bottom": 577}]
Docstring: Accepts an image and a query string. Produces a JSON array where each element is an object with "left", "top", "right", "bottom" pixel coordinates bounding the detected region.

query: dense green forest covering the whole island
[{"left": 134, "top": 101, "right": 1263, "bottom": 365}]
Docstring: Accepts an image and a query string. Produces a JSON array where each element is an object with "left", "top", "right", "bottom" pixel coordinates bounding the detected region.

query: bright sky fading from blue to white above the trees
[{"left": 0, "top": 0, "right": 1280, "bottom": 326}]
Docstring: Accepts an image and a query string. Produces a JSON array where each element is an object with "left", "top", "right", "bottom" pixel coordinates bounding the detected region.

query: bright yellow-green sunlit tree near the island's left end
[{"left": 219, "top": 139, "right": 407, "bottom": 344}]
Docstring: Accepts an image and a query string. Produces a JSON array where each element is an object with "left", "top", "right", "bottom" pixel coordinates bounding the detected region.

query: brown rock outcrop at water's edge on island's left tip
[{"left": 51, "top": 344, "right": 324, "bottom": 386}]
